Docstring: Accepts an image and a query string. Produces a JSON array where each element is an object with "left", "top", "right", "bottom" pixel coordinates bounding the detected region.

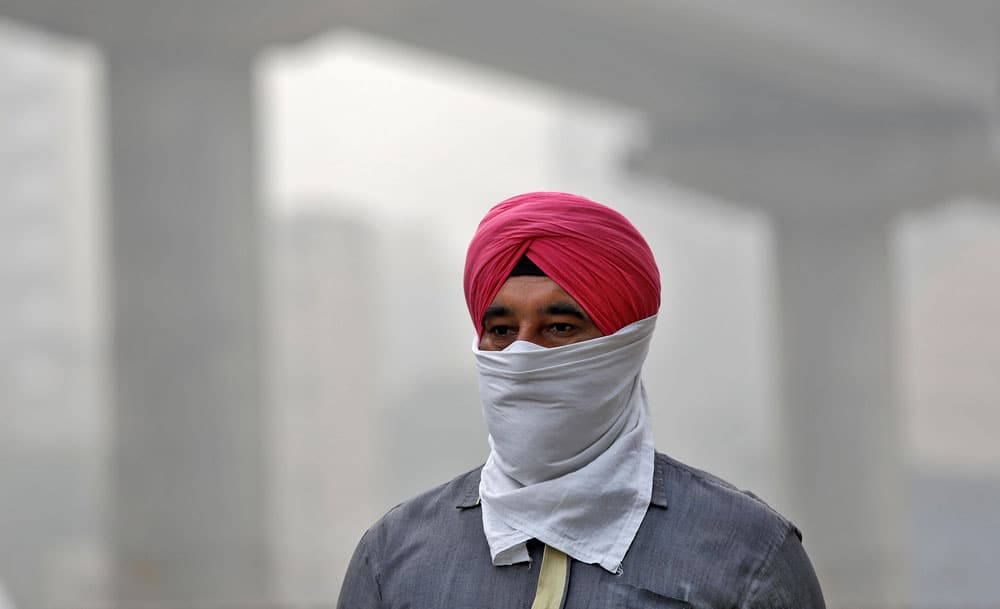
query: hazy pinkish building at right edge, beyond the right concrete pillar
[{"left": 897, "top": 200, "right": 1000, "bottom": 607}]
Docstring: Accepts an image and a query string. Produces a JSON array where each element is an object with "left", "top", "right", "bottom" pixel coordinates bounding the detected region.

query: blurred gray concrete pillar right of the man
[{"left": 775, "top": 211, "right": 905, "bottom": 607}]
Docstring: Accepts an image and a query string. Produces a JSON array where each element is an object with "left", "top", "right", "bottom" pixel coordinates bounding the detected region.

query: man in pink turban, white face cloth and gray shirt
[{"left": 338, "top": 193, "right": 824, "bottom": 609}]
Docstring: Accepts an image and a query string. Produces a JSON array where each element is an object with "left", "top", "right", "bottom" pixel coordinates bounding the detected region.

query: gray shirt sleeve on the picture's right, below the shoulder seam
[{"left": 741, "top": 528, "right": 826, "bottom": 609}]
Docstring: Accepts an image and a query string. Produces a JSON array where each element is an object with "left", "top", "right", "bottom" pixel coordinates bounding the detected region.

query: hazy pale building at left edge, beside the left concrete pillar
[{"left": 0, "top": 22, "right": 108, "bottom": 607}]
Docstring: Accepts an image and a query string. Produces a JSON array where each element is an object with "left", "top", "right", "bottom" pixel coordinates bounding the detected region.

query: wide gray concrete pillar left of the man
[{"left": 107, "top": 47, "right": 268, "bottom": 606}]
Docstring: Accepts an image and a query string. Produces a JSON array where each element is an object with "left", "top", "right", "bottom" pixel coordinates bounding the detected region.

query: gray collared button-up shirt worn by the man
[{"left": 337, "top": 453, "right": 824, "bottom": 609}]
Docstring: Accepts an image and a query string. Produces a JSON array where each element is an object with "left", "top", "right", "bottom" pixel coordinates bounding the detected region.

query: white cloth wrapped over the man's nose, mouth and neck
[{"left": 473, "top": 315, "right": 656, "bottom": 573}]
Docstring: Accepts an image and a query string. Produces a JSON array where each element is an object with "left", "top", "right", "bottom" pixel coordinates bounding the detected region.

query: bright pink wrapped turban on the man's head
[{"left": 465, "top": 192, "right": 660, "bottom": 335}]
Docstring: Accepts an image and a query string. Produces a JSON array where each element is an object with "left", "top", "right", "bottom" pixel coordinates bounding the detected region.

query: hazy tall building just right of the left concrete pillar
[{"left": 266, "top": 204, "right": 384, "bottom": 605}]
